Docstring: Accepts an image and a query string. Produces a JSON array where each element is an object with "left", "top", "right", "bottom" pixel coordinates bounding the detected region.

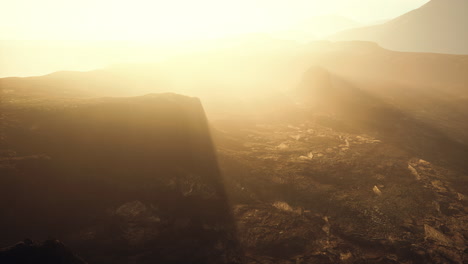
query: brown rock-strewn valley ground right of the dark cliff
[{"left": 213, "top": 119, "right": 468, "bottom": 264}]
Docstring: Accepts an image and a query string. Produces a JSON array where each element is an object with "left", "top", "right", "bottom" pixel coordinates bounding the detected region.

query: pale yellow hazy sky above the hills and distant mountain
[{"left": 0, "top": 0, "right": 428, "bottom": 40}]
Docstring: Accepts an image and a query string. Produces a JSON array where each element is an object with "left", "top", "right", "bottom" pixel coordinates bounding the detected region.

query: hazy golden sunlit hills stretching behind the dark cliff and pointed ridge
[{"left": 0, "top": 40, "right": 468, "bottom": 128}]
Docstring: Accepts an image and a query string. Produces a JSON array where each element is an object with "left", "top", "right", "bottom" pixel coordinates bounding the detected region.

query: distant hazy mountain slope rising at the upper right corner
[{"left": 329, "top": 0, "right": 468, "bottom": 54}]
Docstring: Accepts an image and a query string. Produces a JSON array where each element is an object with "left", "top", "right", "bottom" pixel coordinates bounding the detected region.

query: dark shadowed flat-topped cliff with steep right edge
[{"left": 1, "top": 94, "right": 241, "bottom": 263}]
